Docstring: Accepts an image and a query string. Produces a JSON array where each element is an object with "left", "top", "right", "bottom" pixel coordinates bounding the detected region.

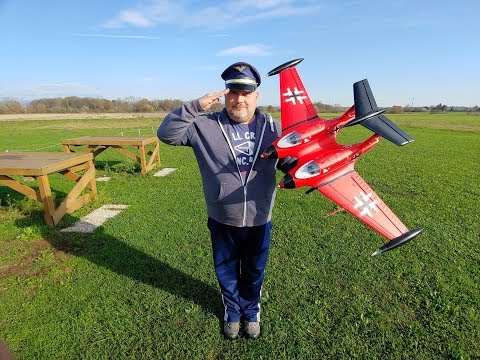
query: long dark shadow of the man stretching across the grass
[{"left": 16, "top": 213, "right": 223, "bottom": 320}]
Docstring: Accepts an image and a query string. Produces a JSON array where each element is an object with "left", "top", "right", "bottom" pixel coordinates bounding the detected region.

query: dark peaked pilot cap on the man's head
[{"left": 222, "top": 62, "right": 261, "bottom": 92}]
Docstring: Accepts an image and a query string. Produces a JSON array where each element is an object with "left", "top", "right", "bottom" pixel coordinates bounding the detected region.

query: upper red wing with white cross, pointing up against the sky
[{"left": 268, "top": 59, "right": 318, "bottom": 131}]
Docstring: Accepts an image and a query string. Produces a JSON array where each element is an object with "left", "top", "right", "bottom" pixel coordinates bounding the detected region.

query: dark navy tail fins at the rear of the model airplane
[{"left": 345, "top": 79, "right": 413, "bottom": 145}]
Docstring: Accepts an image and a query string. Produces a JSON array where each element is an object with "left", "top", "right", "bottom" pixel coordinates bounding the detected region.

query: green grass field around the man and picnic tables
[{"left": 0, "top": 113, "right": 480, "bottom": 359}]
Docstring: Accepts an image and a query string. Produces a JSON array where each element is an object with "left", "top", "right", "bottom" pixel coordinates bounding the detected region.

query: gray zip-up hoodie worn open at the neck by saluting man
[{"left": 157, "top": 100, "right": 281, "bottom": 227}]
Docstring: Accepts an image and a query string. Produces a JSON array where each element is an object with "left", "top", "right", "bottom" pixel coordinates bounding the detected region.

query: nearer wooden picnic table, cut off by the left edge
[{"left": 0, "top": 152, "right": 97, "bottom": 227}]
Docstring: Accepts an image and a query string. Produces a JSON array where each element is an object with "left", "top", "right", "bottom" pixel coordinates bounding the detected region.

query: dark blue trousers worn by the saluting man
[{"left": 208, "top": 218, "right": 272, "bottom": 322}]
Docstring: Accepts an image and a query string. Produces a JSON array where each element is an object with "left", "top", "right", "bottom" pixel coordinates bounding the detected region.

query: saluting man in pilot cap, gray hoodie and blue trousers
[{"left": 157, "top": 62, "right": 281, "bottom": 339}]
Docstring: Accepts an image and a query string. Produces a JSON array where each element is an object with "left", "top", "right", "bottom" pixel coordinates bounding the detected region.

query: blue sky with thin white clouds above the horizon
[{"left": 0, "top": 0, "right": 480, "bottom": 106}]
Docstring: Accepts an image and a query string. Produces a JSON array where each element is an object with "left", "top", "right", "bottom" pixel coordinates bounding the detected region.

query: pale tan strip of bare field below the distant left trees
[{"left": 0, "top": 112, "right": 168, "bottom": 121}]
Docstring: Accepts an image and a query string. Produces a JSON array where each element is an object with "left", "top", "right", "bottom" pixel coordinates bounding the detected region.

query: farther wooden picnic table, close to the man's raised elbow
[{"left": 62, "top": 136, "right": 160, "bottom": 175}]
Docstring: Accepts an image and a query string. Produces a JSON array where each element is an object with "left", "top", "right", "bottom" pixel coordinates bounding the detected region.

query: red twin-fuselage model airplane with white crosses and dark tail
[{"left": 262, "top": 59, "right": 423, "bottom": 256}]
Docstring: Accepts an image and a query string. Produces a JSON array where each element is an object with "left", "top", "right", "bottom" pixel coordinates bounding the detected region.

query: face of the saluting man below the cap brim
[{"left": 225, "top": 90, "right": 258, "bottom": 124}]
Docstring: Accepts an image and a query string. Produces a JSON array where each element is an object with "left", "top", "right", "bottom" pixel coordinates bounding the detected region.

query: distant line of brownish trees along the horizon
[{"left": 0, "top": 96, "right": 474, "bottom": 114}]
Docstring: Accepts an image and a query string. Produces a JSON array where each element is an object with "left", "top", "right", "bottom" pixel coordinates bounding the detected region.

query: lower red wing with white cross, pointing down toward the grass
[{"left": 318, "top": 170, "right": 409, "bottom": 240}]
